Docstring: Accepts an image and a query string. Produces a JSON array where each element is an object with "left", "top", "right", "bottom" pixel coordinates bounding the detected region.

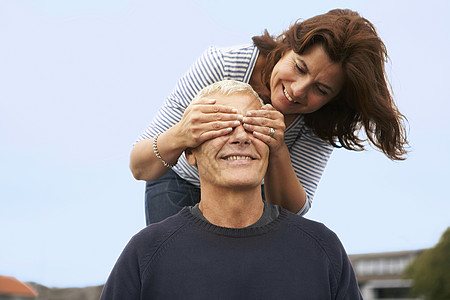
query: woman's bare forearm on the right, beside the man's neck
[{"left": 264, "top": 146, "right": 306, "bottom": 213}]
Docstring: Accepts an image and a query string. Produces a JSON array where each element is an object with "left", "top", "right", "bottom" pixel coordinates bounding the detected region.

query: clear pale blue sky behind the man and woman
[{"left": 0, "top": 0, "right": 450, "bottom": 287}]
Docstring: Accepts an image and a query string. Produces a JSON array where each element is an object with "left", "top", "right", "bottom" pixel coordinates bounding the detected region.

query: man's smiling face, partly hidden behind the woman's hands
[{"left": 186, "top": 94, "right": 269, "bottom": 189}]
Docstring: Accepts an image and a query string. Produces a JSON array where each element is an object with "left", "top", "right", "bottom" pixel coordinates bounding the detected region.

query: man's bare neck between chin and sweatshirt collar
[{"left": 199, "top": 187, "right": 264, "bottom": 228}]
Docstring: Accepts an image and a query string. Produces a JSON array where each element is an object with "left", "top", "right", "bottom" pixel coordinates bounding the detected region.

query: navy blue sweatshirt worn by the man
[{"left": 100, "top": 208, "right": 362, "bottom": 300}]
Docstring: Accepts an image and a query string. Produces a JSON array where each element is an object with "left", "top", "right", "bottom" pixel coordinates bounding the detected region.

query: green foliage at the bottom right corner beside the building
[{"left": 403, "top": 227, "right": 450, "bottom": 300}]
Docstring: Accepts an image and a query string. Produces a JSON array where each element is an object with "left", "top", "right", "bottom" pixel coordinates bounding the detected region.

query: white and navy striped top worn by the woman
[{"left": 137, "top": 45, "right": 333, "bottom": 215}]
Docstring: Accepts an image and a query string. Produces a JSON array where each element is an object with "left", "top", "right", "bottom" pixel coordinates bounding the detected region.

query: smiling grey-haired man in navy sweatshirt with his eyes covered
[{"left": 101, "top": 81, "right": 361, "bottom": 300}]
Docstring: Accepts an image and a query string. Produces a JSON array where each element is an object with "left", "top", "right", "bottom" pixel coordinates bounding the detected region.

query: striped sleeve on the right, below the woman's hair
[{"left": 289, "top": 122, "right": 333, "bottom": 215}]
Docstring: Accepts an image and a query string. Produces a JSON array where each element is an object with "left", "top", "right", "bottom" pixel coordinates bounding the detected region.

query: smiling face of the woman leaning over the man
[{"left": 270, "top": 45, "right": 344, "bottom": 115}]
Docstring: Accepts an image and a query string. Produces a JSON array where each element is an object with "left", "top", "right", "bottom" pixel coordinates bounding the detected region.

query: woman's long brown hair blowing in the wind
[{"left": 253, "top": 9, "right": 408, "bottom": 160}]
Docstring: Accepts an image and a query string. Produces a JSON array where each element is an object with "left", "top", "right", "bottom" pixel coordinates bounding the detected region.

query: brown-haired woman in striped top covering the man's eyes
[{"left": 130, "top": 10, "right": 407, "bottom": 223}]
